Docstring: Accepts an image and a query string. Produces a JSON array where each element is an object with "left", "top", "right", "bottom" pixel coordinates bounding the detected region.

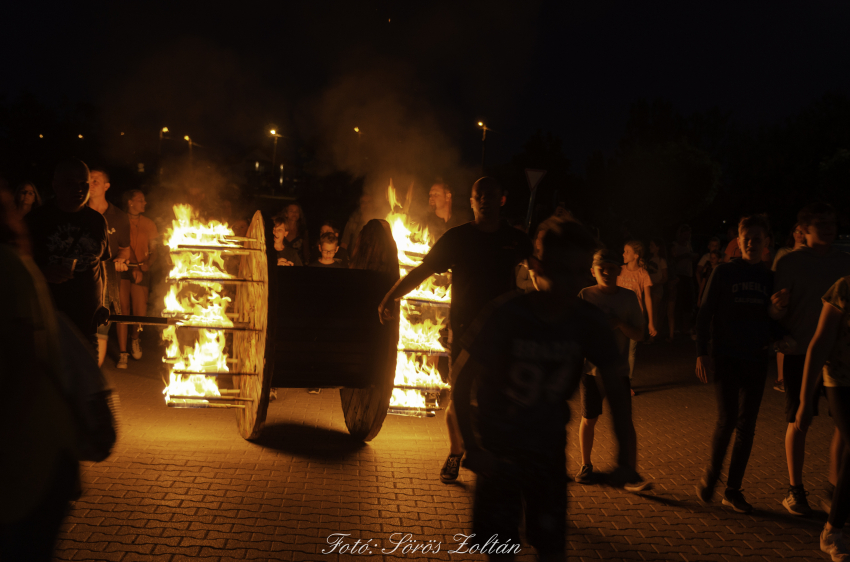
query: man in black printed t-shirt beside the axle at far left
[{"left": 26, "top": 160, "right": 110, "bottom": 346}]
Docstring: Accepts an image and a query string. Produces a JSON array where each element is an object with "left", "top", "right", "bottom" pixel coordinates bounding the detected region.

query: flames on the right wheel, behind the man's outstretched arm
[{"left": 386, "top": 181, "right": 451, "bottom": 409}]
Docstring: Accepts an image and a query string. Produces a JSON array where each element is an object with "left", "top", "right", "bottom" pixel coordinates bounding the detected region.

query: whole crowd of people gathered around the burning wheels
[{"left": 0, "top": 160, "right": 850, "bottom": 560}]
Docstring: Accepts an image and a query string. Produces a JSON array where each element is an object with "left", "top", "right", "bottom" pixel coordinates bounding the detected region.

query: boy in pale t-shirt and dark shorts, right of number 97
[{"left": 575, "top": 246, "right": 646, "bottom": 484}]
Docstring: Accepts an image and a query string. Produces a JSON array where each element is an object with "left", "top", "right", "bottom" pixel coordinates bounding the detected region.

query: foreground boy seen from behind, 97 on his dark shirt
[{"left": 453, "top": 222, "right": 643, "bottom": 560}]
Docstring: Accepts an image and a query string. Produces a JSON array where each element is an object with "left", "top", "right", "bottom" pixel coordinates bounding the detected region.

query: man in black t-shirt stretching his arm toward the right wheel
[{"left": 378, "top": 177, "right": 532, "bottom": 483}]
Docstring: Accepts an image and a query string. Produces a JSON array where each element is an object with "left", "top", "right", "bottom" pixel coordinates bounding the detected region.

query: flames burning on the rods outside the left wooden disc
[{"left": 162, "top": 205, "right": 234, "bottom": 404}]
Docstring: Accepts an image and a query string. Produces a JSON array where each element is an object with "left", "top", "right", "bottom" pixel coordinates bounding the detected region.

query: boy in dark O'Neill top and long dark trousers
[{"left": 696, "top": 215, "right": 789, "bottom": 513}]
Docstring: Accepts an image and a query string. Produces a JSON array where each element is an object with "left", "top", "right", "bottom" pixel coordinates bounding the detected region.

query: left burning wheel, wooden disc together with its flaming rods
[{"left": 163, "top": 206, "right": 271, "bottom": 439}]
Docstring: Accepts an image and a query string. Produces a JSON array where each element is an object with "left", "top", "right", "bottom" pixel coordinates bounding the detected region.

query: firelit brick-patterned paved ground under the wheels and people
[{"left": 57, "top": 331, "right": 832, "bottom": 562}]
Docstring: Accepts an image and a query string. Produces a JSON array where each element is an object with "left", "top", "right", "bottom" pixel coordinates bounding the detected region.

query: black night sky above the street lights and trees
[{"left": 0, "top": 0, "right": 850, "bottom": 172}]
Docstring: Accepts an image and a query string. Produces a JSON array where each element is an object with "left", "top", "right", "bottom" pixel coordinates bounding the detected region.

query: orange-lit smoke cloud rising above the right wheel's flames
[{"left": 305, "top": 61, "right": 480, "bottom": 217}]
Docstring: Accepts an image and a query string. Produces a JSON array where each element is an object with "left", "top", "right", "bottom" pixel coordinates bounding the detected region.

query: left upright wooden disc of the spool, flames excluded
[{"left": 233, "top": 211, "right": 271, "bottom": 439}]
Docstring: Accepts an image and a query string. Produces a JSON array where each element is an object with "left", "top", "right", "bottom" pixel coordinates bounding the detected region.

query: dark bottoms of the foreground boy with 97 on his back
[{"left": 474, "top": 452, "right": 567, "bottom": 554}]
